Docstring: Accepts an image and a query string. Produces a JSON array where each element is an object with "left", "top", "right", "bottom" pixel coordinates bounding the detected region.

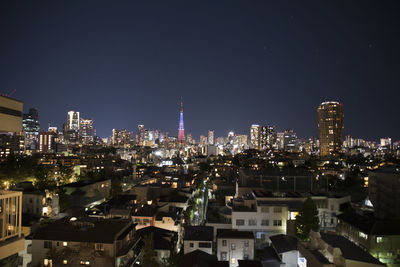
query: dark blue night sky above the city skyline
[{"left": 0, "top": 0, "right": 400, "bottom": 140}]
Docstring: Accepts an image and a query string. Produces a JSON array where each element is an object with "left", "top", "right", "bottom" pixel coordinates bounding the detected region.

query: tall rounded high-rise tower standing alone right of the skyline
[{"left": 317, "top": 101, "right": 344, "bottom": 156}]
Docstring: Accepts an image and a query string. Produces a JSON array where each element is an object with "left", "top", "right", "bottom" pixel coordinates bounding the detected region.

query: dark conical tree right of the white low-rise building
[{"left": 295, "top": 197, "right": 319, "bottom": 241}]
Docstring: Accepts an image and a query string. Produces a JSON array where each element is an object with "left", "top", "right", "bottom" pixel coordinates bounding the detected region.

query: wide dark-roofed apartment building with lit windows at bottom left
[{"left": 31, "top": 217, "right": 137, "bottom": 267}]
